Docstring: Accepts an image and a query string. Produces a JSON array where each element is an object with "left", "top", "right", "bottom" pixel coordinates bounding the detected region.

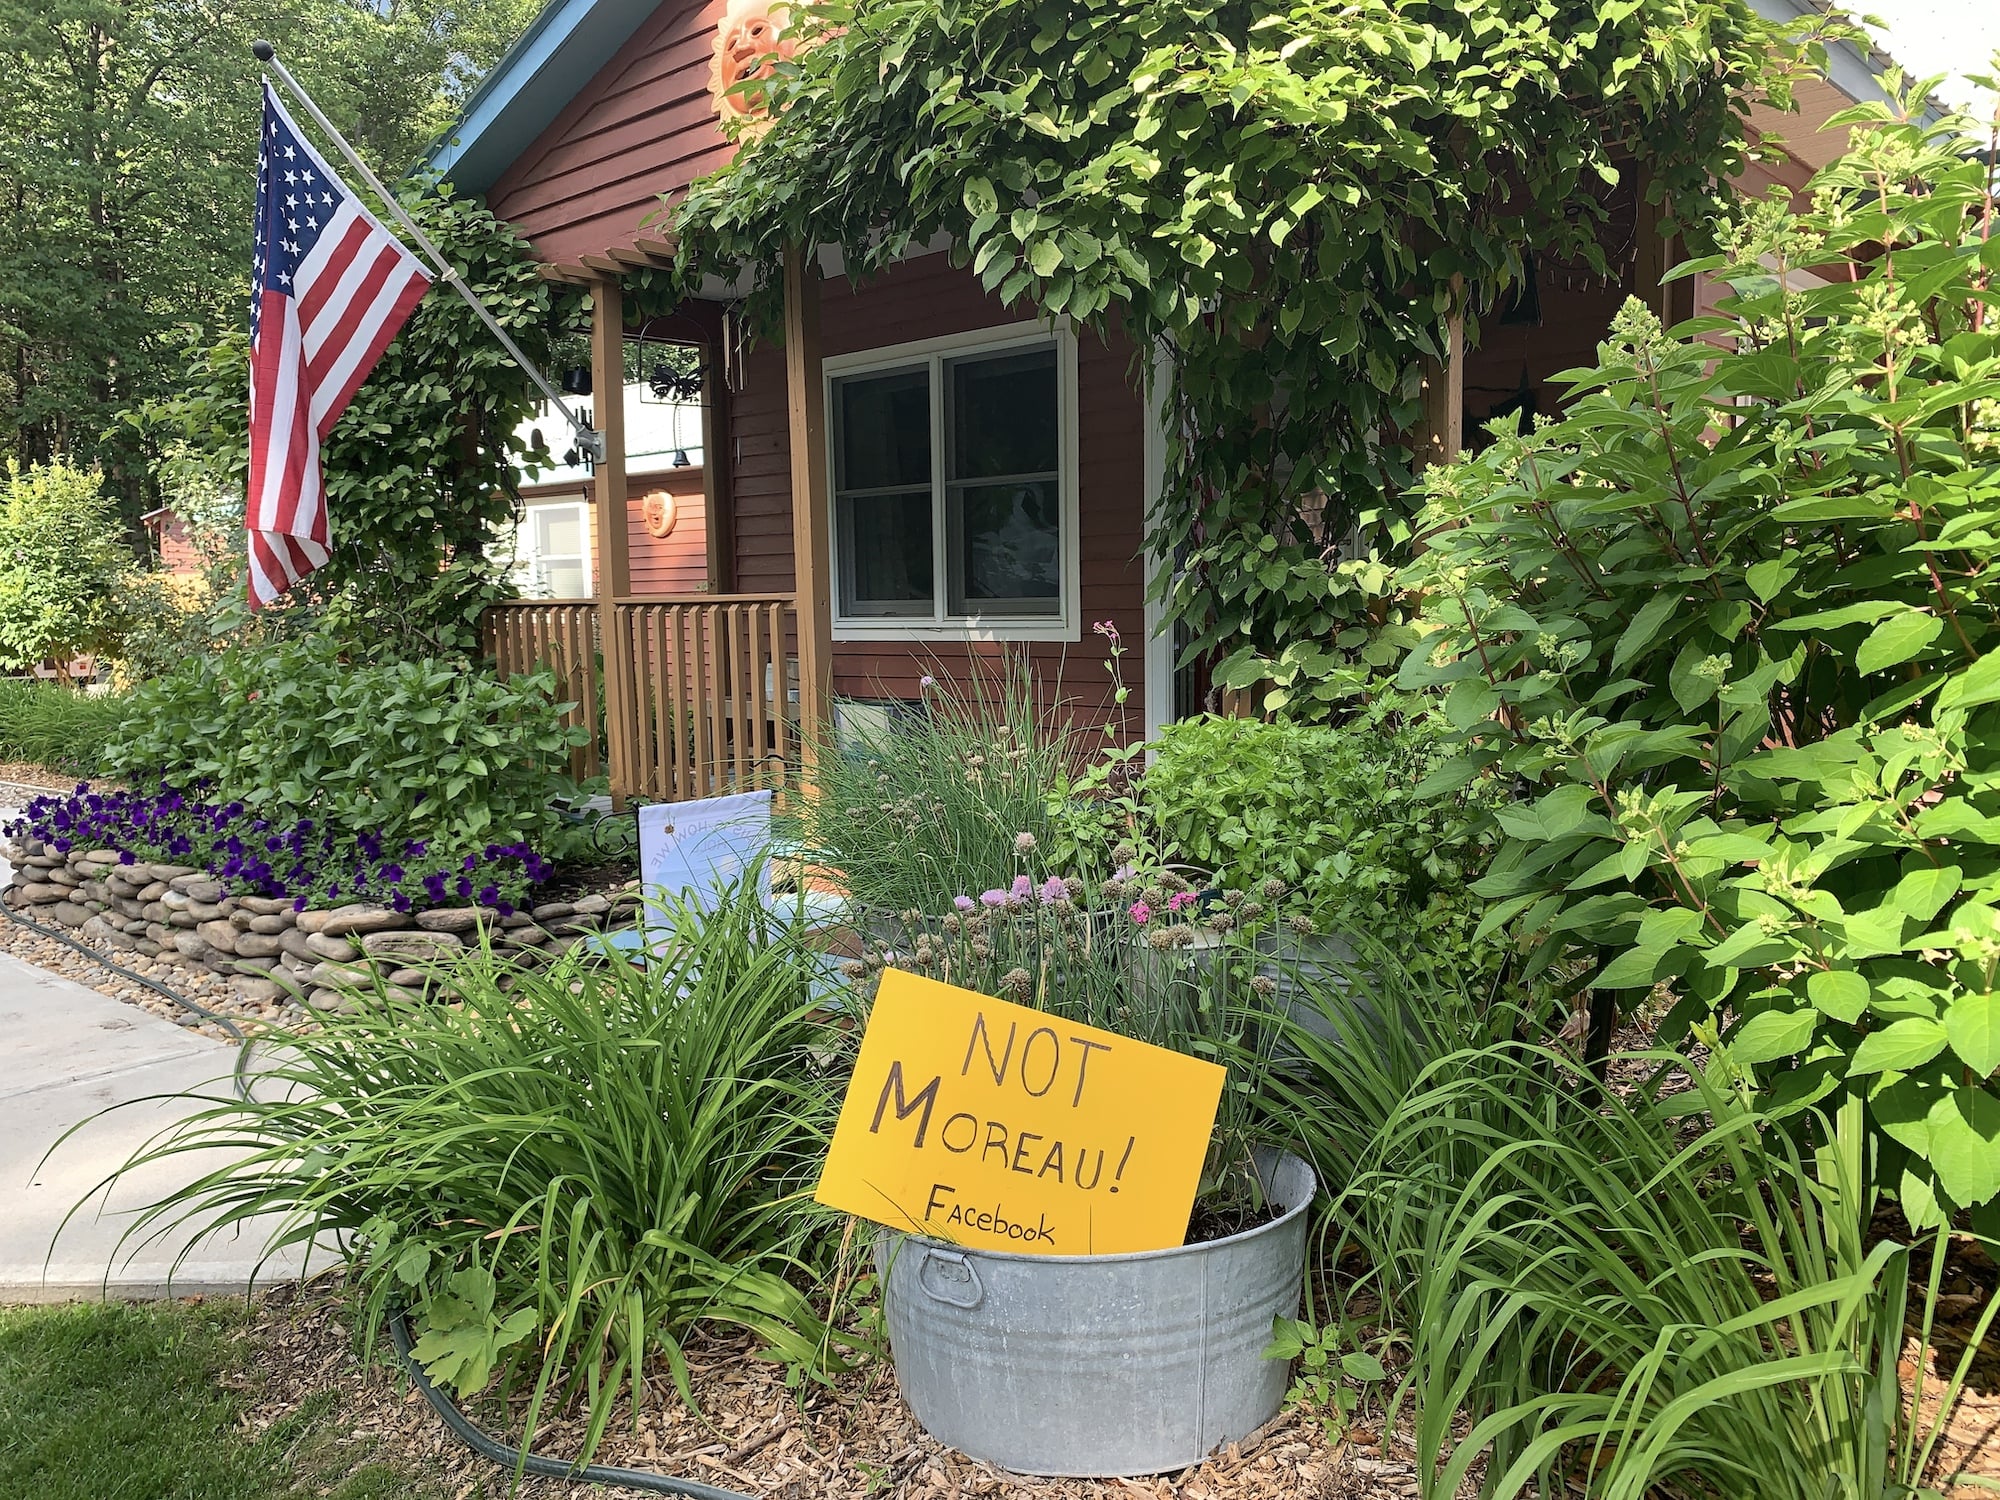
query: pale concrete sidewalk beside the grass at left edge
[{"left": 0, "top": 964, "right": 316, "bottom": 1302}]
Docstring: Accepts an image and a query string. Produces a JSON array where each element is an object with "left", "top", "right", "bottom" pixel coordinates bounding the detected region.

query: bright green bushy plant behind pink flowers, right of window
[{"left": 1140, "top": 692, "right": 1498, "bottom": 980}]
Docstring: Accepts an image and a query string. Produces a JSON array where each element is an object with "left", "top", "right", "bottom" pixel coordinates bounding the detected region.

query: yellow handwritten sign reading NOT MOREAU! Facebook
[{"left": 814, "top": 968, "right": 1224, "bottom": 1256}]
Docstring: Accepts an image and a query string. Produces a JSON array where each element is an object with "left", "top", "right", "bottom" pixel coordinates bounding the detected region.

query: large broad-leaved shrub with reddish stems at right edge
[{"left": 1404, "top": 106, "right": 2000, "bottom": 1224}]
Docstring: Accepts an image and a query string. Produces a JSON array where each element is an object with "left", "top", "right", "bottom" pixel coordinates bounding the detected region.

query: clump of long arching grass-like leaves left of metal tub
[{"left": 105, "top": 880, "right": 846, "bottom": 1460}]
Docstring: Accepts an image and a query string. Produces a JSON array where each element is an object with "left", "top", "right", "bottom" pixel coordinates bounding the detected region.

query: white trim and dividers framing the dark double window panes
[{"left": 822, "top": 318, "right": 1084, "bottom": 640}]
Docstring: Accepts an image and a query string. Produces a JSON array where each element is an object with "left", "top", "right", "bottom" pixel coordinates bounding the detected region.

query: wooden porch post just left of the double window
[{"left": 780, "top": 244, "right": 834, "bottom": 788}]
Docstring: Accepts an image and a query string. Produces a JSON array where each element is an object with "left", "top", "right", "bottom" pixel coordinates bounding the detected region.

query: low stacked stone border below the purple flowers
[{"left": 0, "top": 838, "right": 640, "bottom": 1010}]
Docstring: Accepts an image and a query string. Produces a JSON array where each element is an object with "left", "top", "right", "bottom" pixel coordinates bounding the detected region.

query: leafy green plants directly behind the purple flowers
[{"left": 104, "top": 638, "right": 576, "bottom": 850}]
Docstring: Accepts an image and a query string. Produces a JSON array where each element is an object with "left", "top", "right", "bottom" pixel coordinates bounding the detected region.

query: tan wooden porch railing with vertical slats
[{"left": 482, "top": 594, "right": 798, "bottom": 802}]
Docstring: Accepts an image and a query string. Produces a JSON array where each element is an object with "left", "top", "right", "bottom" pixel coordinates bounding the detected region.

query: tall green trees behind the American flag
[{"left": 0, "top": 0, "right": 534, "bottom": 526}]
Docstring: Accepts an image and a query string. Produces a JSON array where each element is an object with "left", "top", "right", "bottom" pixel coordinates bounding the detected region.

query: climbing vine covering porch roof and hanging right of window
[{"left": 676, "top": 0, "right": 1824, "bottom": 712}]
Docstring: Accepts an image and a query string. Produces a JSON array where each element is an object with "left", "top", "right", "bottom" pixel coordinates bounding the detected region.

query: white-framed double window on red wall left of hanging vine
[{"left": 828, "top": 324, "right": 1076, "bottom": 640}]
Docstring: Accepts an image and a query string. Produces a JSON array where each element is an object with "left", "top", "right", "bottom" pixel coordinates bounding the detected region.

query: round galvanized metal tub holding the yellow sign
[{"left": 876, "top": 1154, "right": 1316, "bottom": 1478}]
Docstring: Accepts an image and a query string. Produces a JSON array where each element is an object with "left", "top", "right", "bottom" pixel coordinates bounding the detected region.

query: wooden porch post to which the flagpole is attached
[{"left": 590, "top": 276, "right": 638, "bottom": 808}]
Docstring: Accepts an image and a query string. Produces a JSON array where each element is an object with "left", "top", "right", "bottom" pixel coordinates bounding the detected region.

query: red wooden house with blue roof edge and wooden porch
[{"left": 432, "top": 0, "right": 1886, "bottom": 796}]
